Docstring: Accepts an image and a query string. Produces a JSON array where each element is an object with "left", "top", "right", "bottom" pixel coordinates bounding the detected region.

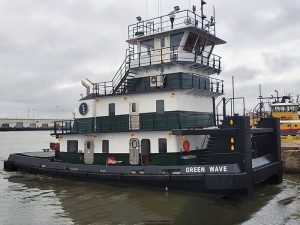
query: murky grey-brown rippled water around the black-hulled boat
[{"left": 0, "top": 131, "right": 300, "bottom": 225}]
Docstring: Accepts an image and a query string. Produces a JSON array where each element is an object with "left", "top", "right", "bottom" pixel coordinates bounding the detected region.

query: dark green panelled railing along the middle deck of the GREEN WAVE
[{"left": 53, "top": 112, "right": 213, "bottom": 136}]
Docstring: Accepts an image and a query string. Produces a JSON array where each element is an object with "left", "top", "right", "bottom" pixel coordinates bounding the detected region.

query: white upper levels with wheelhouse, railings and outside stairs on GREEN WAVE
[{"left": 84, "top": 7, "right": 226, "bottom": 96}]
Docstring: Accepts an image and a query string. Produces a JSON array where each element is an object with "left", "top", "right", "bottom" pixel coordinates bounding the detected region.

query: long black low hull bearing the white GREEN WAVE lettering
[{"left": 4, "top": 152, "right": 282, "bottom": 191}]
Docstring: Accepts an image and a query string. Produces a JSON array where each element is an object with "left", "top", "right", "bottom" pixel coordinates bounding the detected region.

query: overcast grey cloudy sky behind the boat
[{"left": 0, "top": 0, "right": 300, "bottom": 118}]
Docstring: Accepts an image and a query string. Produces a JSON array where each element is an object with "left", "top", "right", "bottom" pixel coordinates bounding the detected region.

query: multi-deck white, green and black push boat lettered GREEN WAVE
[{"left": 4, "top": 1, "right": 282, "bottom": 194}]
